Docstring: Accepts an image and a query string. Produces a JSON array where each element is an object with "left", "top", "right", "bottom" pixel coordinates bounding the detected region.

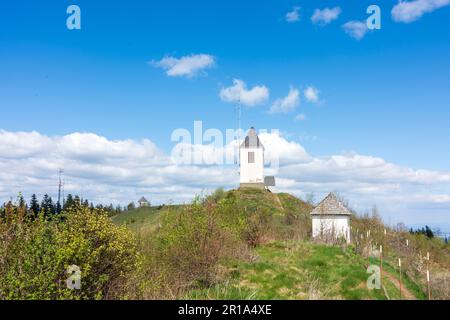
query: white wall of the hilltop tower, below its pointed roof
[{"left": 239, "top": 148, "right": 264, "bottom": 183}]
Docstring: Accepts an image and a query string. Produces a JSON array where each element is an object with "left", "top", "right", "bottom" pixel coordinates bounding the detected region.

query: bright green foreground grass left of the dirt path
[{"left": 189, "top": 242, "right": 385, "bottom": 300}]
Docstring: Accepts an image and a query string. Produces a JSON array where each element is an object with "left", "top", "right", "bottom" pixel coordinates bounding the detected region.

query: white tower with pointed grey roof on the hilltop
[{"left": 239, "top": 127, "right": 265, "bottom": 188}]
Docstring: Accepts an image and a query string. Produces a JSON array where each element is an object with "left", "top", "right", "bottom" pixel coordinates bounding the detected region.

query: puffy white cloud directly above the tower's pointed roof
[{"left": 220, "top": 79, "right": 269, "bottom": 107}]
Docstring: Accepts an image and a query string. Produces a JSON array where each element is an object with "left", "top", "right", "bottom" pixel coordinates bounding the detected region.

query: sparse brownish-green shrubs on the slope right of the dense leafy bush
[{"left": 137, "top": 199, "right": 248, "bottom": 295}]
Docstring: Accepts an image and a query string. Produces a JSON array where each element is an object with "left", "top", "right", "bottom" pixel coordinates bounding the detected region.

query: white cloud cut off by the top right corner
[{"left": 391, "top": 0, "right": 450, "bottom": 23}]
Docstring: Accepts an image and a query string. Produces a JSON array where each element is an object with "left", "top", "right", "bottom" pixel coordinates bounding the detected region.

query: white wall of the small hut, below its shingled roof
[{"left": 312, "top": 215, "right": 350, "bottom": 243}]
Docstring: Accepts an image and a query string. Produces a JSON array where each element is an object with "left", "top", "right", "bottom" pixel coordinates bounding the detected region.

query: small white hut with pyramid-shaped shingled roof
[{"left": 311, "top": 193, "right": 352, "bottom": 243}]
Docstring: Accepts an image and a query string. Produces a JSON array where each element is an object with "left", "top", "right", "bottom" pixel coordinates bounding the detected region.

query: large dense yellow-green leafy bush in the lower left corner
[{"left": 0, "top": 206, "right": 138, "bottom": 299}]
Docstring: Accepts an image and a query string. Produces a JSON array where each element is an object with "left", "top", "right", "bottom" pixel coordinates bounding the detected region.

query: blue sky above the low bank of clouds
[{"left": 0, "top": 0, "right": 450, "bottom": 230}]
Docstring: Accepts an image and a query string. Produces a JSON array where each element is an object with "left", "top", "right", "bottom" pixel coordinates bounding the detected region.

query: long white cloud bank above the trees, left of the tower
[{"left": 0, "top": 130, "right": 237, "bottom": 204}]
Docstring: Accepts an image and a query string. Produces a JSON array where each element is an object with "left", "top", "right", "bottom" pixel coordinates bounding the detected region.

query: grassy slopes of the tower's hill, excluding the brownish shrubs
[{"left": 112, "top": 189, "right": 436, "bottom": 299}]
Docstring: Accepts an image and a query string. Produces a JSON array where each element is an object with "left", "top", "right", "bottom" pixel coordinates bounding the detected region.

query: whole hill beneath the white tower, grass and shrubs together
[{"left": 112, "top": 189, "right": 448, "bottom": 299}]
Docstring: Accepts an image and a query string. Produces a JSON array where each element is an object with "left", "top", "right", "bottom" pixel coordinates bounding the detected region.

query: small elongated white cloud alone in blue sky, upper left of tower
[{"left": 151, "top": 54, "right": 215, "bottom": 78}]
